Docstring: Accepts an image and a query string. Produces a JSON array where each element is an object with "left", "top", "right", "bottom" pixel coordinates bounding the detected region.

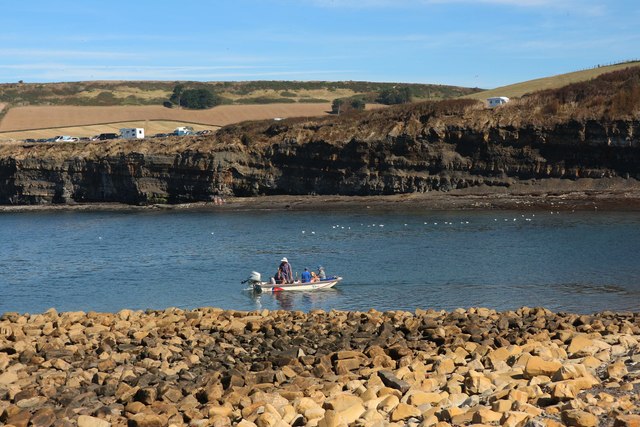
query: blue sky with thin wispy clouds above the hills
[{"left": 0, "top": 0, "right": 640, "bottom": 88}]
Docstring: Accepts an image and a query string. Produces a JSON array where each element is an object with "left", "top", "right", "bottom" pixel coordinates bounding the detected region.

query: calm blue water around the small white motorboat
[{"left": 0, "top": 209, "right": 640, "bottom": 313}]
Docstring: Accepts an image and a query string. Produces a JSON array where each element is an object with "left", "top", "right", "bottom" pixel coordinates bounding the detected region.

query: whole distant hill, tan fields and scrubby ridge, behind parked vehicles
[{"left": 0, "top": 81, "right": 480, "bottom": 140}]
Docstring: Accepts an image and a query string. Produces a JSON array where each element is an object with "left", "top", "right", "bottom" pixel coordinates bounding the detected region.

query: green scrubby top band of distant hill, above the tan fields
[{"left": 0, "top": 81, "right": 480, "bottom": 106}]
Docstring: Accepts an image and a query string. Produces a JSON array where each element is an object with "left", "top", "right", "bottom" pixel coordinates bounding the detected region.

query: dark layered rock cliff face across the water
[{"left": 0, "top": 107, "right": 640, "bottom": 204}]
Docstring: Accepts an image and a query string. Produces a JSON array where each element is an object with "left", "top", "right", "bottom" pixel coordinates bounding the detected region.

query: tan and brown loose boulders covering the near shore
[{"left": 0, "top": 307, "right": 640, "bottom": 427}]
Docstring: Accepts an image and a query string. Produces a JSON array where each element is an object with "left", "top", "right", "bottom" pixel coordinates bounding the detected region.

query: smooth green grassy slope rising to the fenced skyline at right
[{"left": 463, "top": 61, "right": 640, "bottom": 100}]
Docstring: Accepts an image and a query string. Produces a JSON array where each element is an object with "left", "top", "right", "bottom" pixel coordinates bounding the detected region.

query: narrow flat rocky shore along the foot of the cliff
[{"left": 0, "top": 179, "right": 640, "bottom": 212}]
